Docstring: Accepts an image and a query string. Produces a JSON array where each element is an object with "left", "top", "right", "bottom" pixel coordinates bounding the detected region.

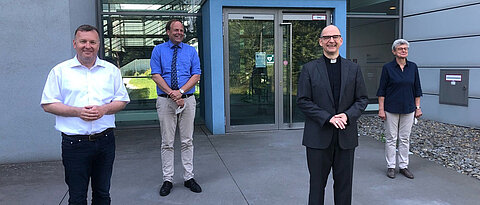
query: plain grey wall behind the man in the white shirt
[{"left": 0, "top": 0, "right": 96, "bottom": 163}]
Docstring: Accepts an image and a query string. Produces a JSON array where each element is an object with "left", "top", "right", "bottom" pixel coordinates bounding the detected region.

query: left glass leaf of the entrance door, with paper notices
[{"left": 224, "top": 12, "right": 276, "bottom": 130}]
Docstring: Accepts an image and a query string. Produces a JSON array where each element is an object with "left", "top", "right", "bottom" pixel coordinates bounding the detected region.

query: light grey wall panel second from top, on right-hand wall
[{"left": 403, "top": 4, "right": 480, "bottom": 40}]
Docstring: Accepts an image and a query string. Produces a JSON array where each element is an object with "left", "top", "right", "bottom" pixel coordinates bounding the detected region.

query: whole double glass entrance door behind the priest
[{"left": 223, "top": 9, "right": 329, "bottom": 132}]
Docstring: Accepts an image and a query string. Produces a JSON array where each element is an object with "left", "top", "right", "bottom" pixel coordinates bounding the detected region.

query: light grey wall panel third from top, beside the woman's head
[{"left": 409, "top": 37, "right": 480, "bottom": 66}]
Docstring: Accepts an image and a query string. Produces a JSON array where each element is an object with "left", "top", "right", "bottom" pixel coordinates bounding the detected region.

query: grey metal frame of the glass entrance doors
[{"left": 222, "top": 7, "right": 334, "bottom": 133}]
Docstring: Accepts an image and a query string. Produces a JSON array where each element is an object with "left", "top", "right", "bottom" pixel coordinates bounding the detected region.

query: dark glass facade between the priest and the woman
[{"left": 347, "top": 0, "right": 401, "bottom": 104}]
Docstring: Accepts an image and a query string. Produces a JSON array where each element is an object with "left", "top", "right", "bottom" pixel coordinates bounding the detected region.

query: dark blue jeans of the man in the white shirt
[{"left": 62, "top": 131, "right": 115, "bottom": 205}]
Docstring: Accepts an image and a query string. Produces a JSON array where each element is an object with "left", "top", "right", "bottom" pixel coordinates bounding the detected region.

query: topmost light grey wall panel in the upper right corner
[{"left": 403, "top": 0, "right": 480, "bottom": 15}]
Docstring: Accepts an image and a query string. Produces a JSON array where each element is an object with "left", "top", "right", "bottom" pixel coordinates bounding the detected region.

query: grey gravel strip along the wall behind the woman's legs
[{"left": 358, "top": 115, "right": 480, "bottom": 180}]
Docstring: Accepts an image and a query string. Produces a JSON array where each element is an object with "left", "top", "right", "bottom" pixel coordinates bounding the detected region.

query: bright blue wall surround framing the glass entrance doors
[{"left": 201, "top": 0, "right": 346, "bottom": 134}]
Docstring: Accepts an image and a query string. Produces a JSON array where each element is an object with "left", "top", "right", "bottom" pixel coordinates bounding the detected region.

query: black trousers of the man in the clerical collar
[{"left": 307, "top": 135, "right": 355, "bottom": 205}]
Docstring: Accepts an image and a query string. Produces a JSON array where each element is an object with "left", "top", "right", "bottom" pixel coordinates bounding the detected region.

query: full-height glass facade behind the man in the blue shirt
[{"left": 101, "top": 0, "right": 202, "bottom": 126}]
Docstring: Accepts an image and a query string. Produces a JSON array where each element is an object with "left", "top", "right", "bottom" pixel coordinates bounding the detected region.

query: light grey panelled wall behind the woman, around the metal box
[{"left": 403, "top": 0, "right": 480, "bottom": 127}]
